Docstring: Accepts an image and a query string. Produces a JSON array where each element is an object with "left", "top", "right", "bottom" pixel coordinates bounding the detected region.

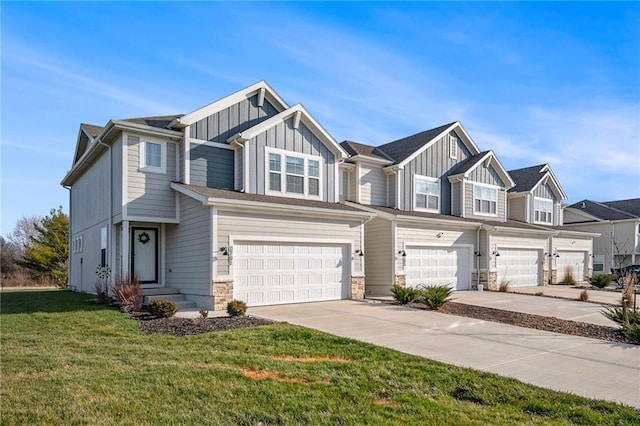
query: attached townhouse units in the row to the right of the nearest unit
[{"left": 341, "top": 122, "right": 593, "bottom": 295}]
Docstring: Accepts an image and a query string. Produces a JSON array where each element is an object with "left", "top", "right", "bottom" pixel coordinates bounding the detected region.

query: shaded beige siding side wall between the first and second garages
[{"left": 364, "top": 218, "right": 397, "bottom": 295}]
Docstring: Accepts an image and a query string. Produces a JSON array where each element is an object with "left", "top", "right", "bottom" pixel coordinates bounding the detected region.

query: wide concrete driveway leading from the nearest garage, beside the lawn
[{"left": 248, "top": 298, "right": 640, "bottom": 407}]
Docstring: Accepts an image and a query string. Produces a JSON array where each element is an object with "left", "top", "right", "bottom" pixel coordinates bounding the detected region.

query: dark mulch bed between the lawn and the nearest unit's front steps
[{"left": 131, "top": 312, "right": 274, "bottom": 337}]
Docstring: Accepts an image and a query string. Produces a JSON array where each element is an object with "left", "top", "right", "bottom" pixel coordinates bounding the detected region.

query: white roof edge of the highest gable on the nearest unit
[{"left": 167, "top": 80, "right": 289, "bottom": 128}]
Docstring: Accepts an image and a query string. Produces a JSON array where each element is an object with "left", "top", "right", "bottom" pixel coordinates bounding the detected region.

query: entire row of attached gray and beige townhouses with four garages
[{"left": 62, "top": 81, "right": 595, "bottom": 310}]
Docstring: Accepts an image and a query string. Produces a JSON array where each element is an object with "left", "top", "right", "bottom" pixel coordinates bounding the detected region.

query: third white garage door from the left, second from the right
[{"left": 497, "top": 248, "right": 542, "bottom": 287}]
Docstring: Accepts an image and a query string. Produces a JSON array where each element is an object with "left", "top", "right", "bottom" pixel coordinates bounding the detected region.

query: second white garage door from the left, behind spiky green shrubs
[{"left": 405, "top": 247, "right": 471, "bottom": 290}]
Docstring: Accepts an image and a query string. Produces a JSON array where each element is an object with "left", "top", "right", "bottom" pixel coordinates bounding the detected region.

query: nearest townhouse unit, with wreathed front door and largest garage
[{"left": 62, "top": 82, "right": 373, "bottom": 309}]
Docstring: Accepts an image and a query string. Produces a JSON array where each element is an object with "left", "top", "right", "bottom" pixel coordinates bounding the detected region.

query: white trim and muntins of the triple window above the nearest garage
[{"left": 264, "top": 147, "right": 324, "bottom": 200}]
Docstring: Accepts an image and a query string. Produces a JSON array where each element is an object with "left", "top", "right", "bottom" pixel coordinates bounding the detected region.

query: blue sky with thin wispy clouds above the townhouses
[{"left": 0, "top": 2, "right": 640, "bottom": 235}]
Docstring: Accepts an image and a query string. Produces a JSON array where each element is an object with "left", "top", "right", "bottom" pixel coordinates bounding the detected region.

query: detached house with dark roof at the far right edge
[{"left": 564, "top": 198, "right": 640, "bottom": 273}]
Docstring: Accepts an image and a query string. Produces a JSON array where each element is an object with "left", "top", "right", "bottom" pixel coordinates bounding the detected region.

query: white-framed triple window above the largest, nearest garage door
[{"left": 266, "top": 149, "right": 322, "bottom": 198}]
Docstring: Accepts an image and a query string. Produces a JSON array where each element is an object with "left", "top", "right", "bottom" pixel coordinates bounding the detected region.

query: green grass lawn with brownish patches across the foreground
[{"left": 0, "top": 290, "right": 640, "bottom": 425}]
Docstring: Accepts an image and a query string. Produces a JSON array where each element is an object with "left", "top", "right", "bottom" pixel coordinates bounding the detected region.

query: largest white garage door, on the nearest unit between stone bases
[{"left": 233, "top": 242, "right": 350, "bottom": 306}]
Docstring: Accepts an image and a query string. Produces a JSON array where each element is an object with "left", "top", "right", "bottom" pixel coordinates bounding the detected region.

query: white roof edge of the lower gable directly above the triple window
[{"left": 227, "top": 104, "right": 348, "bottom": 159}]
